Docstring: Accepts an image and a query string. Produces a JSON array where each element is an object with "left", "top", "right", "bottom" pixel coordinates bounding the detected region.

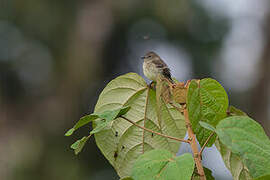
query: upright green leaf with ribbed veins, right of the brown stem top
[{"left": 187, "top": 78, "right": 229, "bottom": 146}]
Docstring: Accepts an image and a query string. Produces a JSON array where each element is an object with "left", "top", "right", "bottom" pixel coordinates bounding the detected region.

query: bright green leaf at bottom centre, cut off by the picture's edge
[{"left": 131, "top": 149, "right": 195, "bottom": 180}]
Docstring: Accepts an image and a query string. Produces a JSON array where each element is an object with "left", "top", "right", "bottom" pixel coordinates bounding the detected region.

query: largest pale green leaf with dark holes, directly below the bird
[{"left": 94, "top": 73, "right": 186, "bottom": 177}]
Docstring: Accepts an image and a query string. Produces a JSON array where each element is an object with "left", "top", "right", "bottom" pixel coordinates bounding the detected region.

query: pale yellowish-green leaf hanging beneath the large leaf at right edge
[{"left": 215, "top": 138, "right": 252, "bottom": 180}]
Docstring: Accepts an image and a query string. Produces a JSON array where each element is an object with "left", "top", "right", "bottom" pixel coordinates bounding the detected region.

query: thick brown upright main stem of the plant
[{"left": 184, "top": 108, "right": 206, "bottom": 180}]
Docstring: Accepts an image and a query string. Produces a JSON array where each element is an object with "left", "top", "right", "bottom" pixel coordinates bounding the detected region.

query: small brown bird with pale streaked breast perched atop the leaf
[{"left": 141, "top": 51, "right": 174, "bottom": 83}]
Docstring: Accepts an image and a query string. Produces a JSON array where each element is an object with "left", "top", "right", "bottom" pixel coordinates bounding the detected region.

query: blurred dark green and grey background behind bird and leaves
[{"left": 0, "top": 0, "right": 270, "bottom": 180}]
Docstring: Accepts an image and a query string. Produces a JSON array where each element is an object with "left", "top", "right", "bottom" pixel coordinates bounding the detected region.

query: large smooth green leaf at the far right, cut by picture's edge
[{"left": 216, "top": 116, "right": 270, "bottom": 178}]
